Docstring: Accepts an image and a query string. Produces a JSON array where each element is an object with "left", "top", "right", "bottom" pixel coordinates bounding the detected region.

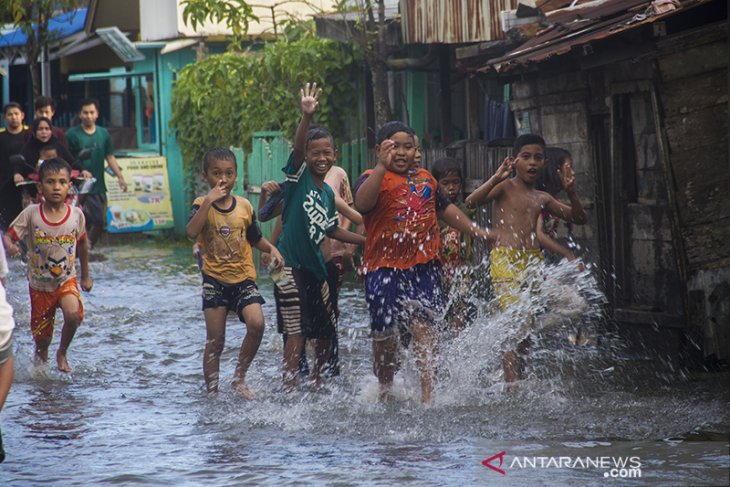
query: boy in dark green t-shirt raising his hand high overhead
[{"left": 274, "top": 83, "right": 365, "bottom": 390}]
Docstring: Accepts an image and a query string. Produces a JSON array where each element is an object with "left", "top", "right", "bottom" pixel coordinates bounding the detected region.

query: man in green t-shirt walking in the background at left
[{"left": 66, "top": 98, "right": 127, "bottom": 246}]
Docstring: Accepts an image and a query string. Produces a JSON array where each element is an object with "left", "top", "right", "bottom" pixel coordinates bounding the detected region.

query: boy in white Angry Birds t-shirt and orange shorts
[{"left": 3, "top": 159, "right": 93, "bottom": 372}]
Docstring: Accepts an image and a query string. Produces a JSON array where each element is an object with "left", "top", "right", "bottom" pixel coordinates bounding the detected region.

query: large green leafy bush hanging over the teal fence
[{"left": 171, "top": 20, "right": 360, "bottom": 179}]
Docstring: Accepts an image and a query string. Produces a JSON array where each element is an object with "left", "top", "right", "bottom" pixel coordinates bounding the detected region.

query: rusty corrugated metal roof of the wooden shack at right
[{"left": 479, "top": 0, "right": 712, "bottom": 72}]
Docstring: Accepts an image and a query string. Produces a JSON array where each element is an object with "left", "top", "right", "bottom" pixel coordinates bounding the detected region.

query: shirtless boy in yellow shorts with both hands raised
[{"left": 466, "top": 134, "right": 586, "bottom": 382}]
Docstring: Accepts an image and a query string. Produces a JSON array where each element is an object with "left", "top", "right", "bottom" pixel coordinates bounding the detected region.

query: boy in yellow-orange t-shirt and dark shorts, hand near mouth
[{"left": 186, "top": 148, "right": 284, "bottom": 399}]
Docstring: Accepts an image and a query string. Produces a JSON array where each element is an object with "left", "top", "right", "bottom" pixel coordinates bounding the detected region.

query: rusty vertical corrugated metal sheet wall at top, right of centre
[{"left": 400, "top": 0, "right": 517, "bottom": 44}]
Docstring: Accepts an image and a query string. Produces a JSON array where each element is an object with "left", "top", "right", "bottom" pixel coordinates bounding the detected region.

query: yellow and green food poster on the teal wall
[{"left": 104, "top": 156, "right": 174, "bottom": 233}]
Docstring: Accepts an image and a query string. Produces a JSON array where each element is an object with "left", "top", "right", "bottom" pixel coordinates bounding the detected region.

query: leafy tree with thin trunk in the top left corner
[{"left": 0, "top": 0, "right": 82, "bottom": 97}]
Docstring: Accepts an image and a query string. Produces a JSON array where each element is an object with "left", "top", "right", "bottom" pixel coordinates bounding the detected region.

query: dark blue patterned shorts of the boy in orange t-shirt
[{"left": 365, "top": 262, "right": 444, "bottom": 332}]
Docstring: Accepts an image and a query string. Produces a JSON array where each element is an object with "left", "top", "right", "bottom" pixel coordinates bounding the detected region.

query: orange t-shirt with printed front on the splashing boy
[{"left": 360, "top": 169, "right": 441, "bottom": 274}]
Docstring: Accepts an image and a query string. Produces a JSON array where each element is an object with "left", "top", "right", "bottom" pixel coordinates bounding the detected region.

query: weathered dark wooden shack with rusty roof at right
[{"left": 462, "top": 0, "right": 730, "bottom": 362}]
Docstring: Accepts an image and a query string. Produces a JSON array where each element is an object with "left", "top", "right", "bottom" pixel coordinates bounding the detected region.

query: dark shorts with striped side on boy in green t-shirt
[{"left": 274, "top": 267, "right": 337, "bottom": 340}]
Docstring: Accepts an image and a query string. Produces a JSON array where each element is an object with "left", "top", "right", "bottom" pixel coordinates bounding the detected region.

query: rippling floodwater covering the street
[{"left": 0, "top": 241, "right": 730, "bottom": 486}]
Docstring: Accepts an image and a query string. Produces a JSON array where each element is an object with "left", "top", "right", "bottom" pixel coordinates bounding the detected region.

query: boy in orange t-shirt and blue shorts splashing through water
[{"left": 355, "top": 122, "right": 492, "bottom": 403}]
